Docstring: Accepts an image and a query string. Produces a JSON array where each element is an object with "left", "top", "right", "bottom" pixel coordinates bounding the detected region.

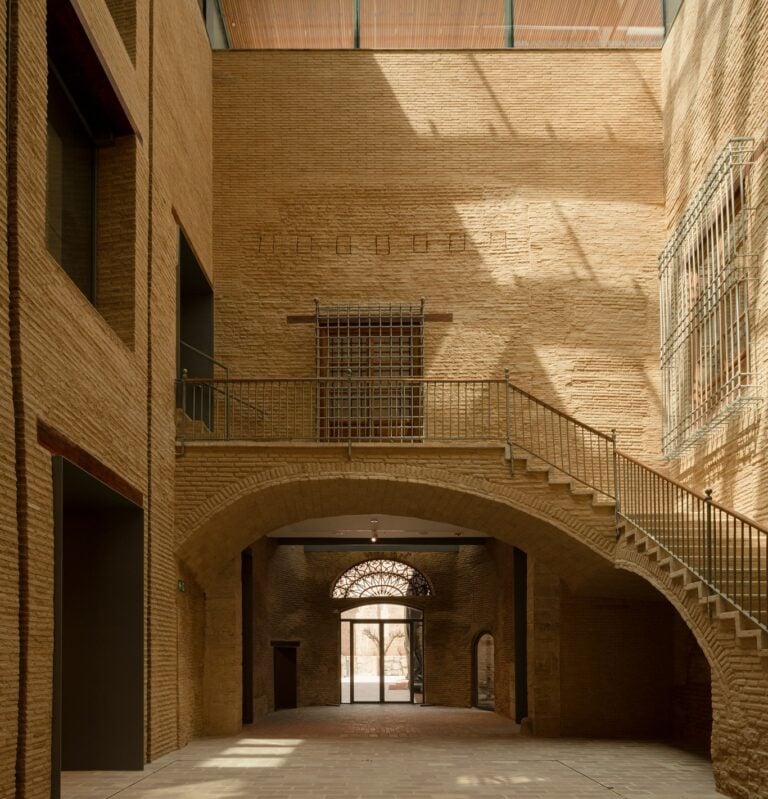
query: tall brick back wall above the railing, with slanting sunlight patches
[{"left": 214, "top": 51, "right": 663, "bottom": 451}]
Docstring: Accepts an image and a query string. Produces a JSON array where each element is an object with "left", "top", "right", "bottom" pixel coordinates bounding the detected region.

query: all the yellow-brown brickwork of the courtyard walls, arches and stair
[{"left": 0, "top": 0, "right": 768, "bottom": 799}]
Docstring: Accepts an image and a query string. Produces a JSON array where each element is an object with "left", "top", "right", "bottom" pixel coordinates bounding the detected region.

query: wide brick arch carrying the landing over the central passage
[{"left": 177, "top": 462, "right": 615, "bottom": 586}]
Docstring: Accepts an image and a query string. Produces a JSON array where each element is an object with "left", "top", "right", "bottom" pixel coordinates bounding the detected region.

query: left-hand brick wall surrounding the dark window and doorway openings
[{"left": 0, "top": 0, "right": 212, "bottom": 798}]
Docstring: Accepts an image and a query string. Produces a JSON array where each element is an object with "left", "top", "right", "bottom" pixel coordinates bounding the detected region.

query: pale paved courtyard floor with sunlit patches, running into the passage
[{"left": 62, "top": 705, "right": 722, "bottom": 799}]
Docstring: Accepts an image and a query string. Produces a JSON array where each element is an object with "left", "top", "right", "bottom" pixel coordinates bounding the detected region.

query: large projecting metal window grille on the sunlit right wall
[{"left": 659, "top": 138, "right": 757, "bottom": 457}]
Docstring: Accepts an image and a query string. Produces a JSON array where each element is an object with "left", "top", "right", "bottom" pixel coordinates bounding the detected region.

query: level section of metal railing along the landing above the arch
[{"left": 179, "top": 377, "right": 508, "bottom": 444}]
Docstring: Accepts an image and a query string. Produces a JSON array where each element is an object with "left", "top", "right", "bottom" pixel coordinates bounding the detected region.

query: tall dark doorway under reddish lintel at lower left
[{"left": 52, "top": 456, "right": 144, "bottom": 797}]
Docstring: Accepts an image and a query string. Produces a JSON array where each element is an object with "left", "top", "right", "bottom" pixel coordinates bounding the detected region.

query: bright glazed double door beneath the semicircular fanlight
[{"left": 341, "top": 602, "right": 424, "bottom": 704}]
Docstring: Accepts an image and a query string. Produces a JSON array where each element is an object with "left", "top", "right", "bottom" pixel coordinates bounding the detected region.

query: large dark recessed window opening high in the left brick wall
[{"left": 45, "top": 0, "right": 136, "bottom": 346}]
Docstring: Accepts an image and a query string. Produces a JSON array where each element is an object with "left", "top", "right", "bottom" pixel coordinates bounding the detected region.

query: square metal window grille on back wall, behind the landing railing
[{"left": 315, "top": 300, "right": 424, "bottom": 441}]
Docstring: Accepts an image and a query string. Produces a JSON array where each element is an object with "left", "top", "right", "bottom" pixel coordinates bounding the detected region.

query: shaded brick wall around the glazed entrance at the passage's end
[{"left": 260, "top": 546, "right": 498, "bottom": 707}]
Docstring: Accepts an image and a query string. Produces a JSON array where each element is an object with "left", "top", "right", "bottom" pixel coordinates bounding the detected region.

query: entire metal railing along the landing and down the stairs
[{"left": 178, "top": 376, "right": 768, "bottom": 631}]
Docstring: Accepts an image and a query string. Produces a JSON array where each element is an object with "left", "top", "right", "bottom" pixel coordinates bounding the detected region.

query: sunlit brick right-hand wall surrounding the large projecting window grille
[{"left": 662, "top": 0, "right": 768, "bottom": 524}]
